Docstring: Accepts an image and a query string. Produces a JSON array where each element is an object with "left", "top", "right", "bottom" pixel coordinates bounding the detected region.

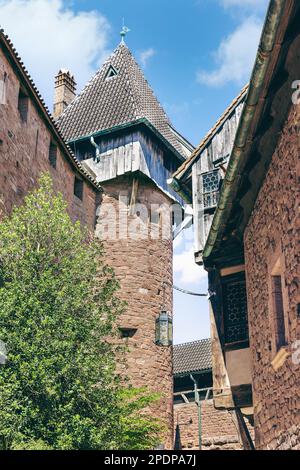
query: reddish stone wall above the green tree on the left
[{"left": 0, "top": 49, "right": 98, "bottom": 230}]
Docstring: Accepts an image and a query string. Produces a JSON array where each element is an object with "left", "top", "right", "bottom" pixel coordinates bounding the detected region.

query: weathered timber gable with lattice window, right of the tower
[{"left": 169, "top": 85, "right": 248, "bottom": 264}]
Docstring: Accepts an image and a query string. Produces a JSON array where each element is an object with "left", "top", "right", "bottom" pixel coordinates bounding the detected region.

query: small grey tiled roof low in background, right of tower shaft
[{"left": 173, "top": 339, "right": 212, "bottom": 375}]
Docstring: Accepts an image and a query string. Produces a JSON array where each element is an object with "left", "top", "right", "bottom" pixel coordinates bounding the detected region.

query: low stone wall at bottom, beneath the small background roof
[{"left": 174, "top": 400, "right": 248, "bottom": 450}]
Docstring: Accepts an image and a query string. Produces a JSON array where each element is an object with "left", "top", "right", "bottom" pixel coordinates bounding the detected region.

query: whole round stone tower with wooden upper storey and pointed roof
[{"left": 58, "top": 42, "right": 193, "bottom": 449}]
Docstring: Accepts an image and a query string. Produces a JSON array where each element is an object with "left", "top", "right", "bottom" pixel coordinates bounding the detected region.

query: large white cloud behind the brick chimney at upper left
[{"left": 0, "top": 0, "right": 110, "bottom": 107}]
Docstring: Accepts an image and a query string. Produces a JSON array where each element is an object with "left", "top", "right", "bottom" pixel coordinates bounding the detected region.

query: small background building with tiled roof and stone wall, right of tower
[{"left": 173, "top": 339, "right": 253, "bottom": 450}]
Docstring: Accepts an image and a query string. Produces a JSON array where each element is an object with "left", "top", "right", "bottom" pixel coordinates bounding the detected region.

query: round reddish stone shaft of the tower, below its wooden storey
[{"left": 97, "top": 176, "right": 173, "bottom": 449}]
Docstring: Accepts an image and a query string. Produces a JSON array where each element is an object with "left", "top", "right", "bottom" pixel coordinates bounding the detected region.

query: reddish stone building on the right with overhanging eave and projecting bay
[{"left": 172, "top": 1, "right": 300, "bottom": 450}]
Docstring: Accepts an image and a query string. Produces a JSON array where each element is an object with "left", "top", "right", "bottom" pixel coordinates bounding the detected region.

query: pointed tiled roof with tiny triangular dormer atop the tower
[{"left": 57, "top": 43, "right": 189, "bottom": 156}]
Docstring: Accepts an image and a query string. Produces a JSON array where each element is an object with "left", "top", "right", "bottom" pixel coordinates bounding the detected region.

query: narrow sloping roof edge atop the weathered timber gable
[{"left": 173, "top": 84, "right": 249, "bottom": 180}]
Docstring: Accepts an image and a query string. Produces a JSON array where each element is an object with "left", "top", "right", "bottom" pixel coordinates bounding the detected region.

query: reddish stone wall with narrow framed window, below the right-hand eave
[{"left": 245, "top": 106, "right": 300, "bottom": 449}]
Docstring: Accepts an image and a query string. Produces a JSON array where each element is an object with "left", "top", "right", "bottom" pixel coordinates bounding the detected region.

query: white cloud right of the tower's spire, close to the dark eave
[{"left": 197, "top": 16, "right": 262, "bottom": 87}]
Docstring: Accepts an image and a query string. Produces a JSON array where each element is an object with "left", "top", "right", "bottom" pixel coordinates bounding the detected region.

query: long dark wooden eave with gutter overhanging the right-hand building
[{"left": 204, "top": 1, "right": 300, "bottom": 269}]
